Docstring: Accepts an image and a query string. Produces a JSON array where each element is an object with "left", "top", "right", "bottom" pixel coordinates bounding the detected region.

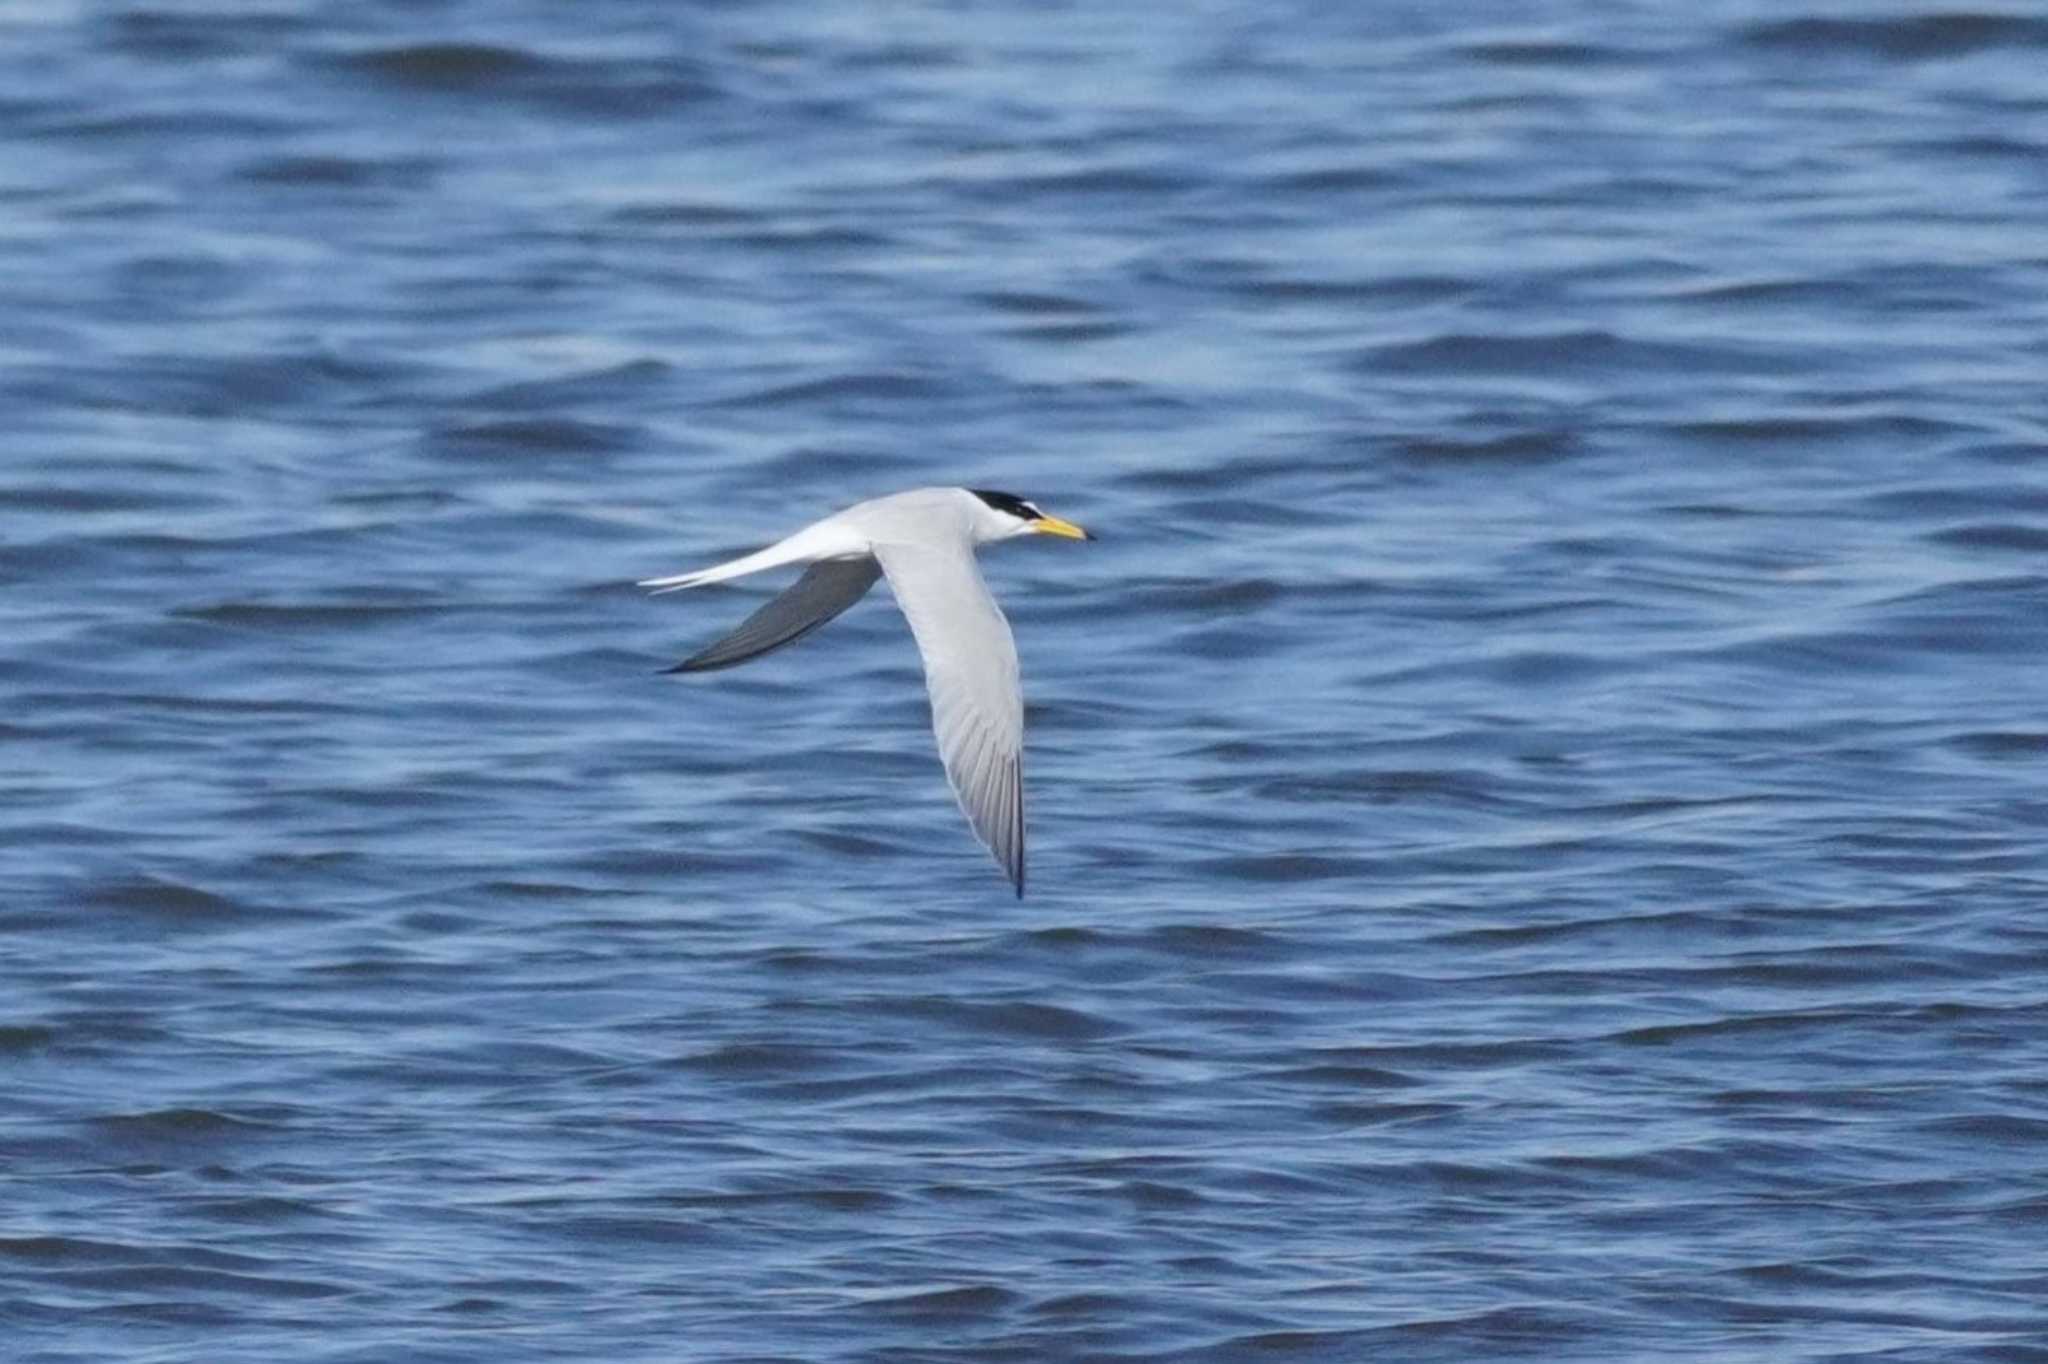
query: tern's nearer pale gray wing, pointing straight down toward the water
[{"left": 874, "top": 545, "right": 1024, "bottom": 899}]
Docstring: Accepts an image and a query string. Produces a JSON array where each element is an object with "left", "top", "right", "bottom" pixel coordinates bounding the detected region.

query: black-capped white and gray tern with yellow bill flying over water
[{"left": 639, "top": 487, "right": 1096, "bottom": 899}]
